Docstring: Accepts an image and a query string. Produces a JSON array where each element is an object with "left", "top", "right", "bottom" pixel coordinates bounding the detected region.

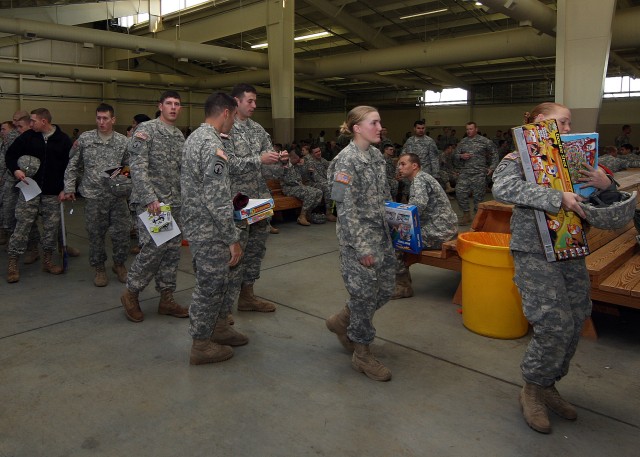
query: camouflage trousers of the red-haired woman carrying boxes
[{"left": 512, "top": 251, "right": 591, "bottom": 387}]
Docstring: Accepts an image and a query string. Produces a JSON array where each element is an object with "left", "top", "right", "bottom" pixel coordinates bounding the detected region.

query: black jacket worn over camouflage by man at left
[{"left": 5, "top": 125, "right": 72, "bottom": 195}]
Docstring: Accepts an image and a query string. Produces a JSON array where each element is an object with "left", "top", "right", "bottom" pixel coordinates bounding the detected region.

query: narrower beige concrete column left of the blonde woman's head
[{"left": 267, "top": 0, "right": 295, "bottom": 144}]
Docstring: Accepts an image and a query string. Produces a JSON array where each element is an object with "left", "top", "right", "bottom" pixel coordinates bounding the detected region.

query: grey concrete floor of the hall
[{"left": 0, "top": 202, "right": 640, "bottom": 457}]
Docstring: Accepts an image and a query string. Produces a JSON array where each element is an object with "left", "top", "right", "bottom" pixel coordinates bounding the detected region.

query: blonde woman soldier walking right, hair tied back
[{"left": 326, "top": 106, "right": 395, "bottom": 381}]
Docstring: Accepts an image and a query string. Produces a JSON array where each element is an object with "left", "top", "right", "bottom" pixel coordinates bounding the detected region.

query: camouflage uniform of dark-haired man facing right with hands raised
[{"left": 224, "top": 119, "right": 273, "bottom": 288}]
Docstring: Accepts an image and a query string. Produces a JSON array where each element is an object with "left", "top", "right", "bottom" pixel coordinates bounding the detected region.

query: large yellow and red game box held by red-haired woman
[{"left": 511, "top": 119, "right": 589, "bottom": 262}]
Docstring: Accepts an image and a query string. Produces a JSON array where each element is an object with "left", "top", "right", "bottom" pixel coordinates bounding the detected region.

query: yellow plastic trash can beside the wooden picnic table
[{"left": 457, "top": 232, "right": 529, "bottom": 339}]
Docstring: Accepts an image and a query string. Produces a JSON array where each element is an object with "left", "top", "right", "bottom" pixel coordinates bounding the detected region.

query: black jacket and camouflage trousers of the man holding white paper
[{"left": 6, "top": 125, "right": 71, "bottom": 256}]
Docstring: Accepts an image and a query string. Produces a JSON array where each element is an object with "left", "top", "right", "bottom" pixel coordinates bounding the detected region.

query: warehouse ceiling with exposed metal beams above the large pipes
[{"left": 0, "top": 0, "right": 640, "bottom": 104}]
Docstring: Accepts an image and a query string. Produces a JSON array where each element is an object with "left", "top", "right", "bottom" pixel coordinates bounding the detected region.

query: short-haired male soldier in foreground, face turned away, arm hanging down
[{"left": 180, "top": 92, "right": 249, "bottom": 365}]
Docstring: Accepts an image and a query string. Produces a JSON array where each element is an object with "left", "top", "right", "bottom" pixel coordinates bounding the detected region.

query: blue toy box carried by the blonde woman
[{"left": 384, "top": 202, "right": 422, "bottom": 254}]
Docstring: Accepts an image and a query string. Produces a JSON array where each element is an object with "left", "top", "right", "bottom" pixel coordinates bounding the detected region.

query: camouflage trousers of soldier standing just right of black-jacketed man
[{"left": 84, "top": 194, "right": 131, "bottom": 267}]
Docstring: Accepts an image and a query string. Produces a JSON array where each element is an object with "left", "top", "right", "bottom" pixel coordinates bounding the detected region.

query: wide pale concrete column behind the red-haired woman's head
[{"left": 556, "top": 0, "right": 616, "bottom": 132}]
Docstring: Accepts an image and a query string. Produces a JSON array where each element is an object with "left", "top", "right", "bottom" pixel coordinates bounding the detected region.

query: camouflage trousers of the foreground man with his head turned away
[{"left": 189, "top": 241, "right": 230, "bottom": 339}]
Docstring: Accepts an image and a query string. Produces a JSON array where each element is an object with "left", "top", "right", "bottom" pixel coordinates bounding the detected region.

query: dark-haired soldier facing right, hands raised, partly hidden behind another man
[{"left": 225, "top": 84, "right": 289, "bottom": 313}]
